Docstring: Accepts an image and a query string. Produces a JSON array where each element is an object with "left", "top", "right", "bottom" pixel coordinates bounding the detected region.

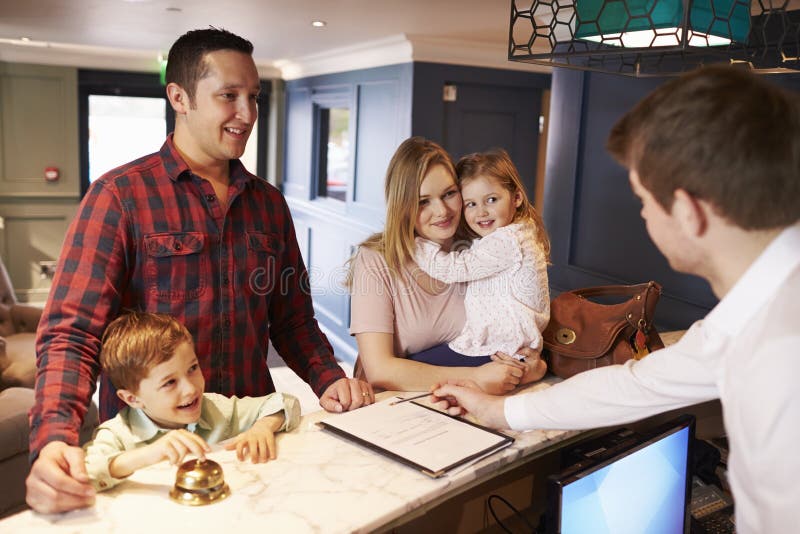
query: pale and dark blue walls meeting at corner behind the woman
[{"left": 283, "top": 63, "right": 550, "bottom": 359}]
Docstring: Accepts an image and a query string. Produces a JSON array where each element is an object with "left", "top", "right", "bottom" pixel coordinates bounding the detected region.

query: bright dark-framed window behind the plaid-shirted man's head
[{"left": 78, "top": 70, "right": 270, "bottom": 195}]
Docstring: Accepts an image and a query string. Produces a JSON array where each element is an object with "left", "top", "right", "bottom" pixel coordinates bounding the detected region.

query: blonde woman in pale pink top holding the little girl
[{"left": 348, "top": 137, "right": 543, "bottom": 394}]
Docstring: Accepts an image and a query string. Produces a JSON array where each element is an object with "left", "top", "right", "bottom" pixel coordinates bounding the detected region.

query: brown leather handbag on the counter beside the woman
[{"left": 542, "top": 281, "right": 664, "bottom": 378}]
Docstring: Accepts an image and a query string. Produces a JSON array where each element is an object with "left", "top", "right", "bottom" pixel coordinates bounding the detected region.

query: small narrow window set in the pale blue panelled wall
[{"left": 314, "top": 95, "right": 353, "bottom": 202}]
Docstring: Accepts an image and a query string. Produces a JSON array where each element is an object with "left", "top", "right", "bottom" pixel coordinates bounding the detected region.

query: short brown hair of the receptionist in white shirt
[{"left": 608, "top": 66, "right": 800, "bottom": 230}]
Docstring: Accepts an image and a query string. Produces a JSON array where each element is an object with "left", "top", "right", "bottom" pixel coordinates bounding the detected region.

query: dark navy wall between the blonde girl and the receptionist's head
[{"left": 544, "top": 69, "right": 800, "bottom": 329}]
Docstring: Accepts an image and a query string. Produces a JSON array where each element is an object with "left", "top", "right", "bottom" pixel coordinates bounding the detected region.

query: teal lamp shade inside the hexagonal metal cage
[{"left": 575, "top": 0, "right": 750, "bottom": 48}]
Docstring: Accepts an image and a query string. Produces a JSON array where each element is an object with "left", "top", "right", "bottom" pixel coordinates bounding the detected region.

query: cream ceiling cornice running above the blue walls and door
[{"left": 275, "top": 34, "right": 552, "bottom": 80}]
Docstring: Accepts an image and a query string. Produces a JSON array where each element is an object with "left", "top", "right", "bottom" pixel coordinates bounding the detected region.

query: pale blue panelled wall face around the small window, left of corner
[{"left": 283, "top": 64, "right": 411, "bottom": 361}]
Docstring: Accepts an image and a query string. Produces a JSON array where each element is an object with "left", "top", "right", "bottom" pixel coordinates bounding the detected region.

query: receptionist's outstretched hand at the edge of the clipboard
[{"left": 431, "top": 379, "right": 508, "bottom": 428}]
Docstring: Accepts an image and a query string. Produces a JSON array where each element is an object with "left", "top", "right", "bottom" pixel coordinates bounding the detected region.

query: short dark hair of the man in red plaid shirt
[{"left": 166, "top": 27, "right": 253, "bottom": 103}]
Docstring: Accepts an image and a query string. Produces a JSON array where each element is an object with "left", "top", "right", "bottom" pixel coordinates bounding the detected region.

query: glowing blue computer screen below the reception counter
[{"left": 561, "top": 427, "right": 690, "bottom": 534}]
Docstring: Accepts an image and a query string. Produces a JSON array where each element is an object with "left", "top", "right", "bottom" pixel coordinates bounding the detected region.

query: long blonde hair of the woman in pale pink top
[{"left": 346, "top": 136, "right": 456, "bottom": 287}]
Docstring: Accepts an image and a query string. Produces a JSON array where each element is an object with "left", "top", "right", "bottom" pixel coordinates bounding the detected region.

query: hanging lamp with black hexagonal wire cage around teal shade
[{"left": 508, "top": 0, "right": 800, "bottom": 76}]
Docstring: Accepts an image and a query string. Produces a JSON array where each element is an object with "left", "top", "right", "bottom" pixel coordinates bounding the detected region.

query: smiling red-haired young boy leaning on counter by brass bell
[{"left": 85, "top": 312, "right": 300, "bottom": 491}]
